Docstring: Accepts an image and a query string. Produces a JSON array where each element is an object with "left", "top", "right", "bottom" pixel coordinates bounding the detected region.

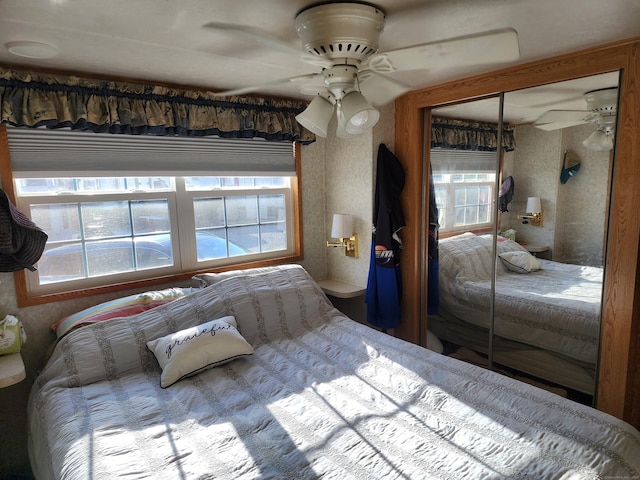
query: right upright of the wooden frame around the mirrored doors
[{"left": 598, "top": 42, "right": 640, "bottom": 428}]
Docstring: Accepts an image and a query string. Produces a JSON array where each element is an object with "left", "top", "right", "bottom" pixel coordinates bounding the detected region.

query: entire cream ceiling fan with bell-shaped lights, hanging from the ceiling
[{"left": 205, "top": 2, "right": 520, "bottom": 137}]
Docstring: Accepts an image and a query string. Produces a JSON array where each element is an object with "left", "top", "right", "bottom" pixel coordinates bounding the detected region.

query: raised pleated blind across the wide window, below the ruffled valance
[{"left": 7, "top": 127, "right": 296, "bottom": 178}]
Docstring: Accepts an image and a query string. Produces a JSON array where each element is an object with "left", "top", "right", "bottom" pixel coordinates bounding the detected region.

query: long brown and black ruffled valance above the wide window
[{"left": 0, "top": 66, "right": 315, "bottom": 143}]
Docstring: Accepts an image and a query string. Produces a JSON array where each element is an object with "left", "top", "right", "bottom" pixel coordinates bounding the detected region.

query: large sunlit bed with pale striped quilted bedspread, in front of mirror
[{"left": 28, "top": 265, "right": 640, "bottom": 480}]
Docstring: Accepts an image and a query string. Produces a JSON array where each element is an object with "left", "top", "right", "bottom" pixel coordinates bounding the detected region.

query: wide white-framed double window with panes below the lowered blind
[{"left": 4, "top": 127, "right": 300, "bottom": 304}]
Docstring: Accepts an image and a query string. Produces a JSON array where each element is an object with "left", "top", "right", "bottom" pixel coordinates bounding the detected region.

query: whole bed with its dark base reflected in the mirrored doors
[{"left": 429, "top": 232, "right": 602, "bottom": 395}]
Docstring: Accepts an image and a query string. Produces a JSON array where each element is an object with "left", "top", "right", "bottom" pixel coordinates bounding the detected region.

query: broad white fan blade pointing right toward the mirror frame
[{"left": 367, "top": 28, "right": 520, "bottom": 73}]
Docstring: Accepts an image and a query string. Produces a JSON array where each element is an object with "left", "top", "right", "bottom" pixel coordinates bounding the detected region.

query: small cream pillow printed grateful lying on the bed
[{"left": 147, "top": 316, "right": 253, "bottom": 388}]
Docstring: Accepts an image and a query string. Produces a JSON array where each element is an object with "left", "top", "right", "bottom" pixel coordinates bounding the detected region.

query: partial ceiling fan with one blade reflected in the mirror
[{"left": 533, "top": 87, "right": 618, "bottom": 152}]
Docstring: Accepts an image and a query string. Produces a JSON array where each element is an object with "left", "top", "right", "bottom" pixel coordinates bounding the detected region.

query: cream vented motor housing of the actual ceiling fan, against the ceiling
[{"left": 296, "top": 3, "right": 385, "bottom": 65}]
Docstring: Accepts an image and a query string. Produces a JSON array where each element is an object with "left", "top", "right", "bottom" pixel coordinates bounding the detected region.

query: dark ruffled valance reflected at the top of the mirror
[{"left": 431, "top": 117, "right": 516, "bottom": 152}]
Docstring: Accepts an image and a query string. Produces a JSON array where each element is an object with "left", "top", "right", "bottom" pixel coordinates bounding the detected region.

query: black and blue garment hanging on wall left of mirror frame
[{"left": 365, "top": 144, "right": 406, "bottom": 329}]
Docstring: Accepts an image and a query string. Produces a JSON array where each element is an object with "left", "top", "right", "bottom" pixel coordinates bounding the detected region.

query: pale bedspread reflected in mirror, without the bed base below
[{"left": 440, "top": 234, "right": 602, "bottom": 364}]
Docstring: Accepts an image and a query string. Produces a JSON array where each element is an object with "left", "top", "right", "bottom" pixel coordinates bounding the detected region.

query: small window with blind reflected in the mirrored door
[{"left": 431, "top": 148, "right": 497, "bottom": 233}]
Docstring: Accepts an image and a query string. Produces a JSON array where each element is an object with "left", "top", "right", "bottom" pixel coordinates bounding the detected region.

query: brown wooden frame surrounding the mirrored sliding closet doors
[{"left": 394, "top": 38, "right": 640, "bottom": 428}]
